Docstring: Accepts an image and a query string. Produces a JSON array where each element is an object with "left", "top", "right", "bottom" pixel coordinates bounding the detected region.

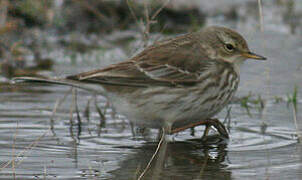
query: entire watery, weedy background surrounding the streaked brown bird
[{"left": 0, "top": 0, "right": 302, "bottom": 179}]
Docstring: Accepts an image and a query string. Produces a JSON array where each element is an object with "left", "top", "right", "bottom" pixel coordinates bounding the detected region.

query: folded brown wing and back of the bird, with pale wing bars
[{"left": 67, "top": 35, "right": 211, "bottom": 87}]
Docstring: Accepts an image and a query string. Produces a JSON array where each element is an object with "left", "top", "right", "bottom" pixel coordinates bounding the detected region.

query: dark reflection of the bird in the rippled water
[{"left": 110, "top": 136, "right": 231, "bottom": 179}]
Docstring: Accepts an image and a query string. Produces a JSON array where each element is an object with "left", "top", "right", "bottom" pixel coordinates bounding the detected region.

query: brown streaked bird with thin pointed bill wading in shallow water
[{"left": 14, "top": 26, "right": 266, "bottom": 138}]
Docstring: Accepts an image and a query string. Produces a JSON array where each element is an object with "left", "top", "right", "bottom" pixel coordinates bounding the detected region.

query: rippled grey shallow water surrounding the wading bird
[{"left": 0, "top": 0, "right": 302, "bottom": 180}]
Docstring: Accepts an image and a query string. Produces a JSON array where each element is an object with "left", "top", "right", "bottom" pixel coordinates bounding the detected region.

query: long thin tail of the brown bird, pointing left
[{"left": 11, "top": 77, "right": 104, "bottom": 94}]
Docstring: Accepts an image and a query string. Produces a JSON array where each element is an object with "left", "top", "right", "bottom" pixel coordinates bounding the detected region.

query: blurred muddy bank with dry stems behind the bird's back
[{"left": 0, "top": 0, "right": 302, "bottom": 81}]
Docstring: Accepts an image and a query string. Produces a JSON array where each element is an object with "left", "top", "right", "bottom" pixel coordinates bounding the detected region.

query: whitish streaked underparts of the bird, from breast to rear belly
[{"left": 106, "top": 68, "right": 239, "bottom": 128}]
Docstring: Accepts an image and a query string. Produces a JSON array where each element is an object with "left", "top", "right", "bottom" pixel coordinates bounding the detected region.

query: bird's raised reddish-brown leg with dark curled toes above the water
[{"left": 171, "top": 119, "right": 229, "bottom": 139}]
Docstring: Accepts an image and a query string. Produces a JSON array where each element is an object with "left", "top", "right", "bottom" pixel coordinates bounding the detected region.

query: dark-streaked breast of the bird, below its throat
[{"left": 170, "top": 68, "right": 239, "bottom": 127}]
